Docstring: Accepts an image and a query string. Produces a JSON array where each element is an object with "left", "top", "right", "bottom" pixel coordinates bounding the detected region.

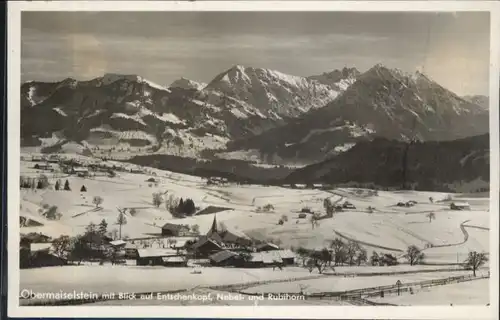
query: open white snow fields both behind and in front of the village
[{"left": 20, "top": 155, "right": 489, "bottom": 304}]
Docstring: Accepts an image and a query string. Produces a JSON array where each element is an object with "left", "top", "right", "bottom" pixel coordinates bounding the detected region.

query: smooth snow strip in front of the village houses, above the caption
[{"left": 20, "top": 264, "right": 318, "bottom": 293}]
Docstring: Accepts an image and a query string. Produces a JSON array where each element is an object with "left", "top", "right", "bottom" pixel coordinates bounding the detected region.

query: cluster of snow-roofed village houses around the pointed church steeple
[{"left": 21, "top": 212, "right": 295, "bottom": 268}]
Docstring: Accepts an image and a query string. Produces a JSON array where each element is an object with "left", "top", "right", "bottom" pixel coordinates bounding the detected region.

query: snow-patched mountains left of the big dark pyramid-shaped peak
[{"left": 21, "top": 66, "right": 353, "bottom": 157}]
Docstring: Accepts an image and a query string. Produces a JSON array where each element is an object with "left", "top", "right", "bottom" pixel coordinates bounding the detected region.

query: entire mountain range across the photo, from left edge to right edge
[{"left": 21, "top": 64, "right": 489, "bottom": 190}]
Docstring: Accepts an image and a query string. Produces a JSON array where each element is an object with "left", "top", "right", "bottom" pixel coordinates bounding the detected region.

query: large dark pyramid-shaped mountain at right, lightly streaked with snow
[{"left": 228, "top": 64, "right": 489, "bottom": 163}]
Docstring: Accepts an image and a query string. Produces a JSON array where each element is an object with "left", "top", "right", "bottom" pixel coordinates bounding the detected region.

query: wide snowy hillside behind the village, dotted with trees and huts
[{"left": 21, "top": 158, "right": 489, "bottom": 263}]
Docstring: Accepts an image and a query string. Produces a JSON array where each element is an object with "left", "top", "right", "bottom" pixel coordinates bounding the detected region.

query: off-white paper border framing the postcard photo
[{"left": 7, "top": 1, "right": 500, "bottom": 319}]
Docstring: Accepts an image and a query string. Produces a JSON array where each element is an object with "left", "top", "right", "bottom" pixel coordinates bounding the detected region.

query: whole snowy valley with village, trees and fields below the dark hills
[{"left": 20, "top": 155, "right": 489, "bottom": 304}]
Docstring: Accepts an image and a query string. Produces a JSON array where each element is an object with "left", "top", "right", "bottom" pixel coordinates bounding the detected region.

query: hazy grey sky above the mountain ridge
[{"left": 21, "top": 12, "right": 490, "bottom": 95}]
